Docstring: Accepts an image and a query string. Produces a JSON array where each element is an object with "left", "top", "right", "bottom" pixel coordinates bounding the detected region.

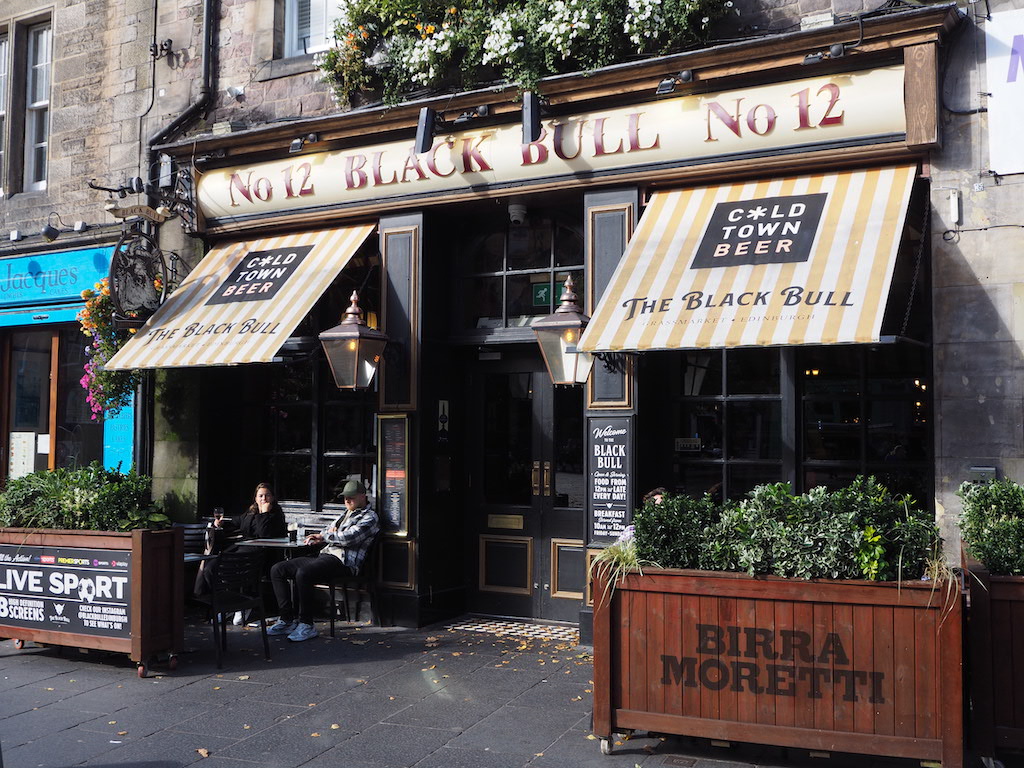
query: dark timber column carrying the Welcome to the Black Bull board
[{"left": 580, "top": 188, "right": 640, "bottom": 644}]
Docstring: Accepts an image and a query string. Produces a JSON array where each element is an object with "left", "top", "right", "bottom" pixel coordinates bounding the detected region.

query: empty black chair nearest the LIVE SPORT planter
[{"left": 196, "top": 551, "right": 270, "bottom": 670}]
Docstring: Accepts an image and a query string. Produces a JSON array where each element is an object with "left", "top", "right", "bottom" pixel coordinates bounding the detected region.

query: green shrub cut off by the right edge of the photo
[{"left": 956, "top": 479, "right": 1024, "bottom": 575}]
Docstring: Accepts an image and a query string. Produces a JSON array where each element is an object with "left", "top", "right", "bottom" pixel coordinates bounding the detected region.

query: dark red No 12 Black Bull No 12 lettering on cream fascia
[{"left": 227, "top": 82, "right": 846, "bottom": 208}]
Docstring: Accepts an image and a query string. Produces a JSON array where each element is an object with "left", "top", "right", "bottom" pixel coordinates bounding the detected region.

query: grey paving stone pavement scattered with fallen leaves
[{"left": 0, "top": 623, "right": 987, "bottom": 768}]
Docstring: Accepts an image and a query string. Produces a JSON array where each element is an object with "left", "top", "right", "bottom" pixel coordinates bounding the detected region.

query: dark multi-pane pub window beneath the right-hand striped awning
[{"left": 638, "top": 342, "right": 933, "bottom": 505}]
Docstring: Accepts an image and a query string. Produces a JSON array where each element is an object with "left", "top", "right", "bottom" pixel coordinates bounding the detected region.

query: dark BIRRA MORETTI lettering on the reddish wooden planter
[{"left": 662, "top": 624, "right": 886, "bottom": 703}]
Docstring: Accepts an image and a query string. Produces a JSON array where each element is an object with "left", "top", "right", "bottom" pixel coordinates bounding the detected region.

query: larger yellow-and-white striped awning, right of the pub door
[{"left": 580, "top": 166, "right": 916, "bottom": 351}]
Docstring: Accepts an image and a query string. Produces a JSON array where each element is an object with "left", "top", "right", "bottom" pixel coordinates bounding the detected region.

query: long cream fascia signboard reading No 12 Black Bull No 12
[{"left": 197, "top": 66, "right": 906, "bottom": 220}]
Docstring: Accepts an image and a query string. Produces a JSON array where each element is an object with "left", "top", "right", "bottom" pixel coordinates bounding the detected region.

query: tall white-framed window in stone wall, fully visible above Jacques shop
[{"left": 24, "top": 23, "right": 51, "bottom": 190}]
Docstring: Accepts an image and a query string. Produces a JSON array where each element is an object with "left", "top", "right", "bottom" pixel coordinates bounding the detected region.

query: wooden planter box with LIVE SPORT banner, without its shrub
[{"left": 0, "top": 528, "right": 184, "bottom": 676}]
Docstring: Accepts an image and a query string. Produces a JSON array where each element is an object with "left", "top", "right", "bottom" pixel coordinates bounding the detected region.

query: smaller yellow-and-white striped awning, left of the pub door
[{"left": 106, "top": 224, "right": 374, "bottom": 371}]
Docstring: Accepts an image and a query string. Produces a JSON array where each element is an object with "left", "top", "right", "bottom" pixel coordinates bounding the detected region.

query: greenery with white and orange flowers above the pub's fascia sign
[{"left": 317, "top": 0, "right": 734, "bottom": 104}]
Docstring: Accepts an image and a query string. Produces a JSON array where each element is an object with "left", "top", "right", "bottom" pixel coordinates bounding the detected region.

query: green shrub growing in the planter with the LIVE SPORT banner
[{"left": 0, "top": 462, "right": 170, "bottom": 530}]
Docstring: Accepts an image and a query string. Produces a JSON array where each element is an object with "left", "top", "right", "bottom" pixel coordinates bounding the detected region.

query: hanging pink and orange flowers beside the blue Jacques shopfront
[{"left": 78, "top": 278, "right": 138, "bottom": 421}]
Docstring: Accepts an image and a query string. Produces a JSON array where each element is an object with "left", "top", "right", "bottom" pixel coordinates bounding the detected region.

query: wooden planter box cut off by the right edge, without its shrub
[{"left": 968, "top": 568, "right": 1024, "bottom": 758}]
